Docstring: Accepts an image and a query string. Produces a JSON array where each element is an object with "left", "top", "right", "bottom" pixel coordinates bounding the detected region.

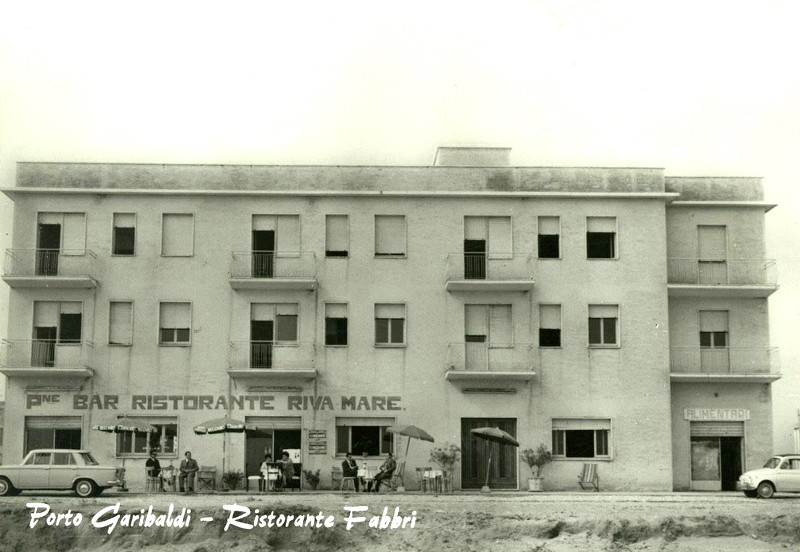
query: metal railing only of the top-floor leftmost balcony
[{"left": 3, "top": 249, "right": 97, "bottom": 277}]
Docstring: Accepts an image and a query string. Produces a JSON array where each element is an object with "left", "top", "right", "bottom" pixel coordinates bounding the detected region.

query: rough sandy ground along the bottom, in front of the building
[{"left": 0, "top": 492, "right": 800, "bottom": 552}]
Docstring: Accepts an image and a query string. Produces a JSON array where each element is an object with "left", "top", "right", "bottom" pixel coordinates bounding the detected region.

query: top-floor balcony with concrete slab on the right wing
[{"left": 667, "top": 258, "right": 778, "bottom": 297}]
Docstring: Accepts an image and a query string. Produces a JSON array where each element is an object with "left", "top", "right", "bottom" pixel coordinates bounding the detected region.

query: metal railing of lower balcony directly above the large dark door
[{"left": 446, "top": 342, "right": 535, "bottom": 372}]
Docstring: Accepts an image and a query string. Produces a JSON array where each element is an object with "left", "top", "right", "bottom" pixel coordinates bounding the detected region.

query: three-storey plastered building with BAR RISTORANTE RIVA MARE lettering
[{"left": 1, "top": 148, "right": 779, "bottom": 490}]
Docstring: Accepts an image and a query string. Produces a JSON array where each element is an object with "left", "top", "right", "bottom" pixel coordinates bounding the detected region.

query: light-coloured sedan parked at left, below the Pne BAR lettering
[{"left": 0, "top": 449, "right": 122, "bottom": 498}]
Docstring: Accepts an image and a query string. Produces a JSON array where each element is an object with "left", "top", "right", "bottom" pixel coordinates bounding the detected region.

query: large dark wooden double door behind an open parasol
[{"left": 461, "top": 418, "right": 517, "bottom": 489}]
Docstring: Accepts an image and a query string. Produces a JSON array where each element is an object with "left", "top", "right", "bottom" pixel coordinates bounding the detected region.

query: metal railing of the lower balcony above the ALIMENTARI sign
[{"left": 670, "top": 347, "right": 780, "bottom": 374}]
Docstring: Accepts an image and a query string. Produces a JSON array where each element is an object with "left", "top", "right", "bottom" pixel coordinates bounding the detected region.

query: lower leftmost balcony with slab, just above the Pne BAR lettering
[{"left": 0, "top": 339, "right": 94, "bottom": 379}]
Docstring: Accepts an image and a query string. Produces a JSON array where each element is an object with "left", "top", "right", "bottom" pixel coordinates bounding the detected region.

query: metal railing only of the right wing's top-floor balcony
[{"left": 667, "top": 257, "right": 778, "bottom": 286}]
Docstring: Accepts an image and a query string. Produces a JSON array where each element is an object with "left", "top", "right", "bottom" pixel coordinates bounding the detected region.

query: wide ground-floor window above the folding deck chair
[{"left": 553, "top": 418, "right": 611, "bottom": 458}]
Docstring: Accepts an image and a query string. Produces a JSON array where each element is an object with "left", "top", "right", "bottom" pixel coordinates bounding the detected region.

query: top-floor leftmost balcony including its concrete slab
[{"left": 3, "top": 249, "right": 97, "bottom": 289}]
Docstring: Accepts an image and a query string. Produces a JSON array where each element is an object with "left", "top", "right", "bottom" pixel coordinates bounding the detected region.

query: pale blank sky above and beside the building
[{"left": 0, "top": 0, "right": 800, "bottom": 448}]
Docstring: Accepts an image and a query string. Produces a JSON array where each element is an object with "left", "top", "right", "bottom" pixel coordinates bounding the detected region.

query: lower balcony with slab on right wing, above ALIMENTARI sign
[{"left": 670, "top": 347, "right": 781, "bottom": 383}]
